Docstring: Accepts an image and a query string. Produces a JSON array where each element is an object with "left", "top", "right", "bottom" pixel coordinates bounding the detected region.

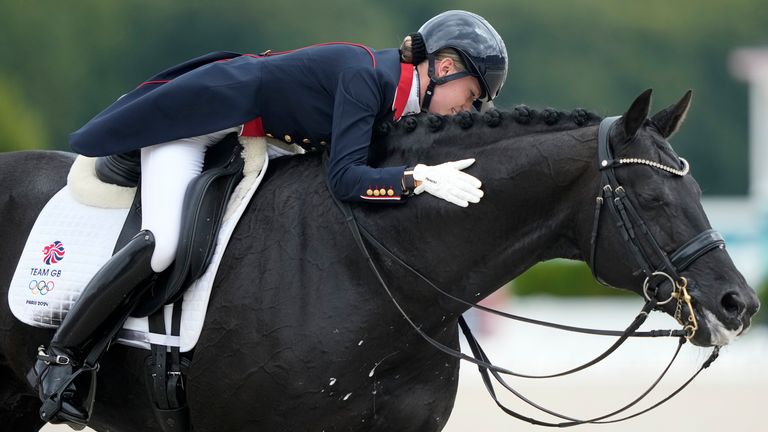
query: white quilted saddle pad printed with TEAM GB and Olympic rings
[{"left": 8, "top": 138, "right": 278, "bottom": 352}]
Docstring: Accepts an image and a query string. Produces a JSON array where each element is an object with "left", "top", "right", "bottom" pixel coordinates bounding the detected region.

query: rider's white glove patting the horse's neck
[{"left": 413, "top": 159, "right": 483, "bottom": 207}]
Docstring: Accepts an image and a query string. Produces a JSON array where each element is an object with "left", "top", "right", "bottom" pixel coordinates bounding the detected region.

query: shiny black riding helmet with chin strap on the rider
[{"left": 411, "top": 10, "right": 508, "bottom": 110}]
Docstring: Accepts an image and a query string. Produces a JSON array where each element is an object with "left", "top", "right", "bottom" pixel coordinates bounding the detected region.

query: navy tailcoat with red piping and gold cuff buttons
[{"left": 70, "top": 43, "right": 405, "bottom": 202}]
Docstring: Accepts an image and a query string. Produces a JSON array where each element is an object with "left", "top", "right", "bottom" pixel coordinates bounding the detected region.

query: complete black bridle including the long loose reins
[{"left": 323, "top": 117, "right": 725, "bottom": 427}]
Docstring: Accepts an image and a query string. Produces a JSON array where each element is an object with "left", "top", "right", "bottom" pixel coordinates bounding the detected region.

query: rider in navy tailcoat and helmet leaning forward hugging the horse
[{"left": 29, "top": 11, "right": 507, "bottom": 424}]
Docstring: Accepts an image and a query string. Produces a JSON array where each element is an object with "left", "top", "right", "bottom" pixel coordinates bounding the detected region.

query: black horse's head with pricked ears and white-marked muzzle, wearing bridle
[{"left": 590, "top": 90, "right": 759, "bottom": 346}]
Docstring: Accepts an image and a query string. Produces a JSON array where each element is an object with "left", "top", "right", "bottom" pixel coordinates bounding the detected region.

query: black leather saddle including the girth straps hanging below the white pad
[{"left": 95, "top": 133, "right": 244, "bottom": 432}]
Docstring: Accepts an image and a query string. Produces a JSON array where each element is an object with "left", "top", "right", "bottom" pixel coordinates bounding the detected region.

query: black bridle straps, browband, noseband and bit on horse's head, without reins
[{"left": 590, "top": 117, "right": 725, "bottom": 340}]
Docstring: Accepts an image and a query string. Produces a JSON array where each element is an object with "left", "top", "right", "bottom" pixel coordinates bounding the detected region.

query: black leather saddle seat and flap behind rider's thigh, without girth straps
[{"left": 96, "top": 133, "right": 244, "bottom": 317}]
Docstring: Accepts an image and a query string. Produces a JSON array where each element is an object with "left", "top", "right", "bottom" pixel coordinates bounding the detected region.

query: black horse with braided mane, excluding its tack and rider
[{"left": 0, "top": 91, "right": 758, "bottom": 432}]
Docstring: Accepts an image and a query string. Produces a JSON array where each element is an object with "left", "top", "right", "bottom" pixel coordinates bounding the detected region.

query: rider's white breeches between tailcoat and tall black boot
[{"left": 141, "top": 127, "right": 240, "bottom": 272}]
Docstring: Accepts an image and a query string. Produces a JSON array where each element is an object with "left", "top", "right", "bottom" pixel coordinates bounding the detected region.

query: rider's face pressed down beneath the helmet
[{"left": 419, "top": 58, "right": 480, "bottom": 115}]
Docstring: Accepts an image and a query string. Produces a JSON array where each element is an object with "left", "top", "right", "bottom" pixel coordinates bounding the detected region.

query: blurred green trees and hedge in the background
[{"left": 0, "top": 0, "right": 768, "bottom": 308}]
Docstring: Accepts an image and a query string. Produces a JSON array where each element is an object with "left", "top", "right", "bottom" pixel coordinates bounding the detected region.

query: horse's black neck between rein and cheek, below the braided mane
[{"left": 366, "top": 127, "right": 598, "bottom": 312}]
